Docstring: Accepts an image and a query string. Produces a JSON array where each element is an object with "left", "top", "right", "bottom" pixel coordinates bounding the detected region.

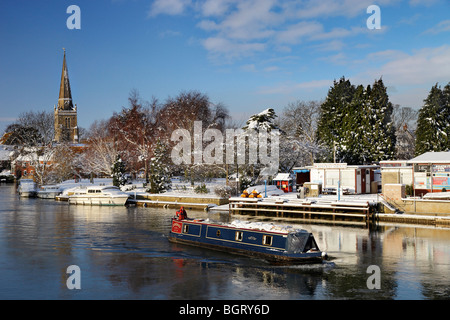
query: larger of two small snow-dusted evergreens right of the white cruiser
[{"left": 150, "top": 139, "right": 172, "bottom": 193}]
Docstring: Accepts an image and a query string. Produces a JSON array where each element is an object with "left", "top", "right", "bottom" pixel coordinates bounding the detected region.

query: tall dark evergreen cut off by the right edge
[{"left": 416, "top": 83, "right": 450, "bottom": 155}]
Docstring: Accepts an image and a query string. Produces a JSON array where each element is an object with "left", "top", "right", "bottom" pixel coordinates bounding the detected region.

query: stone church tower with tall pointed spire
[{"left": 54, "top": 49, "right": 79, "bottom": 143}]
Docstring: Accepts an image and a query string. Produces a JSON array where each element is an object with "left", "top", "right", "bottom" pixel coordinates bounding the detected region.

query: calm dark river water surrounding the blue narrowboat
[{"left": 0, "top": 184, "right": 450, "bottom": 300}]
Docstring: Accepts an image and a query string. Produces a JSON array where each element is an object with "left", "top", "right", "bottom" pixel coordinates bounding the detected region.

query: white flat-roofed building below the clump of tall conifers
[{"left": 293, "top": 163, "right": 381, "bottom": 194}]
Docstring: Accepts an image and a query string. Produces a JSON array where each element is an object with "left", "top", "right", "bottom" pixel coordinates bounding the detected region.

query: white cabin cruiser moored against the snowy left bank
[{"left": 69, "top": 186, "right": 129, "bottom": 206}]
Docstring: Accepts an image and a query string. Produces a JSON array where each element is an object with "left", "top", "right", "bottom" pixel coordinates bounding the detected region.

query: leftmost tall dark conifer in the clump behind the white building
[{"left": 317, "top": 77, "right": 355, "bottom": 161}]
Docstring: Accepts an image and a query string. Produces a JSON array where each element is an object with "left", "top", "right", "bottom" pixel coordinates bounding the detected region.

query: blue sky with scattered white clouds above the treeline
[{"left": 0, "top": 0, "right": 450, "bottom": 132}]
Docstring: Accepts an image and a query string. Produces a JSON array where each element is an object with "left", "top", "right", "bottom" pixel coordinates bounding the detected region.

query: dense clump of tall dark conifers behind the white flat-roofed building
[{"left": 318, "top": 78, "right": 395, "bottom": 164}]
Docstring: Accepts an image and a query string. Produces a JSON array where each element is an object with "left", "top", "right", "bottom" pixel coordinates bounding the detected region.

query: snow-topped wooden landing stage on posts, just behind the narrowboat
[{"left": 229, "top": 198, "right": 374, "bottom": 223}]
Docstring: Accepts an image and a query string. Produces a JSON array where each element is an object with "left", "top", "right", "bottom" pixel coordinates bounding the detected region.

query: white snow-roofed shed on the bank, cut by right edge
[{"left": 407, "top": 152, "right": 450, "bottom": 196}]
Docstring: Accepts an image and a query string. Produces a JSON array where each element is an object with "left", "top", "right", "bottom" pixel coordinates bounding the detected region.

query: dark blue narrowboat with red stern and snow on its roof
[{"left": 169, "top": 218, "right": 326, "bottom": 264}]
